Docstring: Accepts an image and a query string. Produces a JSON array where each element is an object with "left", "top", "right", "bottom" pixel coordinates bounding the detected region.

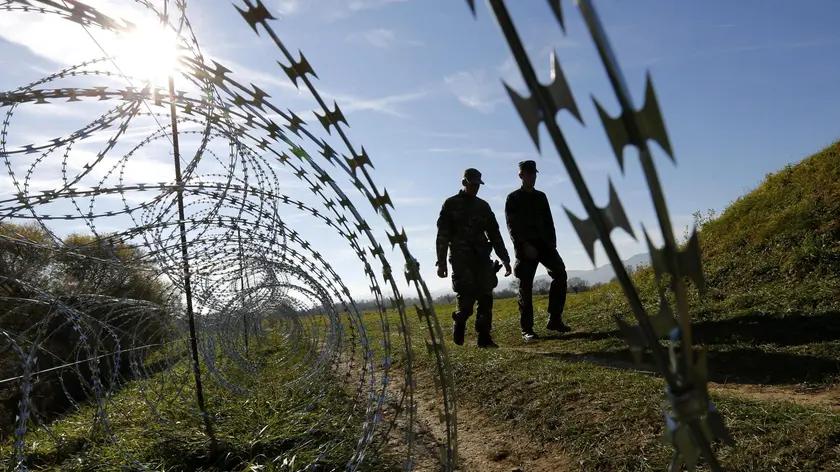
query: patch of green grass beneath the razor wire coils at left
[{"left": 0, "top": 331, "right": 398, "bottom": 472}]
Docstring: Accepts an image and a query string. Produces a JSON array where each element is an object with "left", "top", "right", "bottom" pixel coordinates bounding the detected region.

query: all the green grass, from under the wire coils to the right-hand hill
[{"left": 8, "top": 143, "right": 840, "bottom": 472}]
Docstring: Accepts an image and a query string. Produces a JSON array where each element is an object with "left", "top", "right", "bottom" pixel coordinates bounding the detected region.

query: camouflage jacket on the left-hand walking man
[{"left": 435, "top": 190, "right": 510, "bottom": 265}]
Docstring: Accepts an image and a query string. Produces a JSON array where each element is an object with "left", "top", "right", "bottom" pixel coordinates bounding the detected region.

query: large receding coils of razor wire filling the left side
[{"left": 0, "top": 0, "right": 456, "bottom": 470}]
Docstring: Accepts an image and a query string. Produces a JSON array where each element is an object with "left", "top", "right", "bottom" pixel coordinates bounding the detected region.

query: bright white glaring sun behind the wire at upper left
[{"left": 109, "top": 26, "right": 181, "bottom": 87}]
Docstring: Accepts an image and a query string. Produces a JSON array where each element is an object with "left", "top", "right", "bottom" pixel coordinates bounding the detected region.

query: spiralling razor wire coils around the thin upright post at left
[{"left": 0, "top": 0, "right": 456, "bottom": 470}]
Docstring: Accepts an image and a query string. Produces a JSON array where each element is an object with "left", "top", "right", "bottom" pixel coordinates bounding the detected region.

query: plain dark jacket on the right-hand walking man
[{"left": 505, "top": 188, "right": 557, "bottom": 257}]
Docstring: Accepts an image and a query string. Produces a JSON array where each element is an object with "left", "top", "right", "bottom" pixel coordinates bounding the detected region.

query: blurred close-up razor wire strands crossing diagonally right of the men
[{"left": 467, "top": 0, "right": 734, "bottom": 472}]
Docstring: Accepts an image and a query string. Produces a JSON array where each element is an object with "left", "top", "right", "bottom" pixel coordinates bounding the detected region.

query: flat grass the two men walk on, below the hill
[{"left": 386, "top": 294, "right": 840, "bottom": 471}]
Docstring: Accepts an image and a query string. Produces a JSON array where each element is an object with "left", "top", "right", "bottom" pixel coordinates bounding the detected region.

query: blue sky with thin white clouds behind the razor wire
[{"left": 0, "top": 0, "right": 840, "bottom": 306}]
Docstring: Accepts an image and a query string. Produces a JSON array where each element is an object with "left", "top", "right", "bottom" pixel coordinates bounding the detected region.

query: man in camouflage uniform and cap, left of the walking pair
[{"left": 435, "top": 168, "right": 511, "bottom": 347}]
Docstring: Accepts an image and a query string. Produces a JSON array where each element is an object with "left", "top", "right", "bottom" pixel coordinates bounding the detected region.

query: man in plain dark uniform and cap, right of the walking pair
[{"left": 505, "top": 161, "right": 571, "bottom": 341}]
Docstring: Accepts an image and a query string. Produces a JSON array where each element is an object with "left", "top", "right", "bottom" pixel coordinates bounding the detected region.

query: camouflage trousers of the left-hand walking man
[{"left": 450, "top": 258, "right": 499, "bottom": 333}]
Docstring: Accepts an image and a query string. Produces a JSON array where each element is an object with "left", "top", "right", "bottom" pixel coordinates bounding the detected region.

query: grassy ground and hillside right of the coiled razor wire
[{"left": 370, "top": 143, "right": 840, "bottom": 472}]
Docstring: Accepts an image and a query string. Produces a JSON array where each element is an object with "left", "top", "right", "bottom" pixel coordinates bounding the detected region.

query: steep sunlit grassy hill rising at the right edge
[{"left": 701, "top": 143, "right": 840, "bottom": 309}]
